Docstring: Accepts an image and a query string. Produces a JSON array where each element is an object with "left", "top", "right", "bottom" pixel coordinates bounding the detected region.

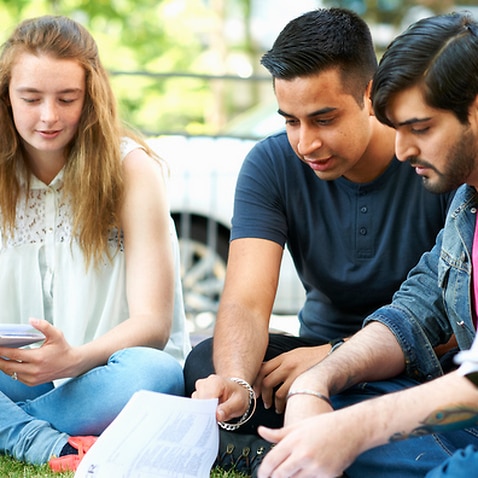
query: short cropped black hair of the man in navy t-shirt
[{"left": 261, "top": 8, "right": 377, "bottom": 103}]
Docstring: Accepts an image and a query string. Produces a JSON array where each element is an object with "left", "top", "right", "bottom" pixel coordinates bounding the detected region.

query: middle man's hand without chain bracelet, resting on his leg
[{"left": 254, "top": 344, "right": 330, "bottom": 413}]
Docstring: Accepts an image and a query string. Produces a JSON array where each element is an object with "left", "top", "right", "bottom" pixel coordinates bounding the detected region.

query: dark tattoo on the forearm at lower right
[{"left": 390, "top": 406, "right": 478, "bottom": 442}]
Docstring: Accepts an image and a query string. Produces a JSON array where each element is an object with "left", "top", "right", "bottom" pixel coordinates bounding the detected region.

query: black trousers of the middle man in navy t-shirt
[{"left": 184, "top": 334, "right": 323, "bottom": 433}]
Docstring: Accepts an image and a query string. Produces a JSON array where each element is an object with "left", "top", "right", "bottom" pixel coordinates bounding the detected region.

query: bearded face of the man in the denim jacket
[{"left": 387, "top": 86, "right": 478, "bottom": 193}]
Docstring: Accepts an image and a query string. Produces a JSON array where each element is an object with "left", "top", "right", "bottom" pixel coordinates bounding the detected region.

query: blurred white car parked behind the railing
[{"left": 148, "top": 135, "right": 305, "bottom": 331}]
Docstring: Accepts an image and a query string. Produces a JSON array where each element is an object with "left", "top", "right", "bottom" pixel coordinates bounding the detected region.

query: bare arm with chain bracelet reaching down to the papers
[{"left": 193, "top": 238, "right": 283, "bottom": 421}]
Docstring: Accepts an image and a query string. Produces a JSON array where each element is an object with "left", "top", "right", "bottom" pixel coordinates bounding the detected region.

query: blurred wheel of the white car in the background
[{"left": 173, "top": 214, "right": 229, "bottom": 333}]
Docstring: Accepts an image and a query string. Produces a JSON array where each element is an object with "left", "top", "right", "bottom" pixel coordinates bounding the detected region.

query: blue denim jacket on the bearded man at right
[{"left": 364, "top": 185, "right": 478, "bottom": 381}]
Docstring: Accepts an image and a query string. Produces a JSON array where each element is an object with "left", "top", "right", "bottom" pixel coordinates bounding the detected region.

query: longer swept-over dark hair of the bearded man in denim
[{"left": 371, "top": 12, "right": 478, "bottom": 126}]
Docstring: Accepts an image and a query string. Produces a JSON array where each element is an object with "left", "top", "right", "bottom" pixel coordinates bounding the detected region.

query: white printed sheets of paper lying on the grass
[{"left": 75, "top": 391, "right": 219, "bottom": 478}]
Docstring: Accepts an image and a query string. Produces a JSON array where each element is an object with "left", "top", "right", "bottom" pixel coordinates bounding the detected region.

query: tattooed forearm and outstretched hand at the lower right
[{"left": 258, "top": 372, "right": 478, "bottom": 478}]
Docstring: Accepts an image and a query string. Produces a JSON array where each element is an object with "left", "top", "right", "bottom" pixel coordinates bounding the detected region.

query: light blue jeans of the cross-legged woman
[{"left": 0, "top": 347, "right": 184, "bottom": 464}]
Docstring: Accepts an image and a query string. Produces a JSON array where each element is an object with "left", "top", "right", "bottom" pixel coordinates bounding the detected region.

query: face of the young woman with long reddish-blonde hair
[{"left": 9, "top": 53, "right": 86, "bottom": 167}]
